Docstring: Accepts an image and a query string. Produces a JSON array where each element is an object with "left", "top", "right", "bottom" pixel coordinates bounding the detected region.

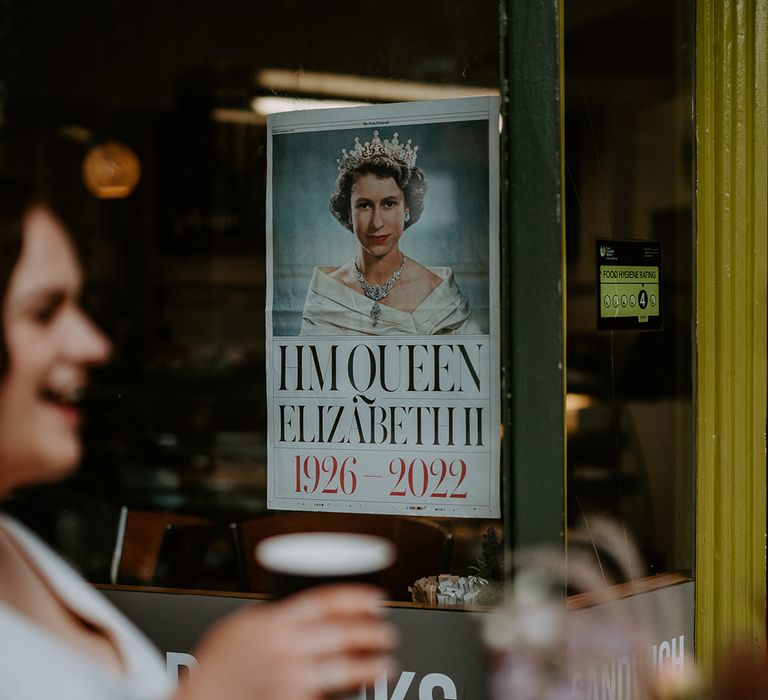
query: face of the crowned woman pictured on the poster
[{"left": 350, "top": 173, "right": 406, "bottom": 258}]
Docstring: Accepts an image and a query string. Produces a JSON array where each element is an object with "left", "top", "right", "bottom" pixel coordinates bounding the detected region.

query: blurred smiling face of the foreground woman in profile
[{"left": 0, "top": 207, "right": 109, "bottom": 493}]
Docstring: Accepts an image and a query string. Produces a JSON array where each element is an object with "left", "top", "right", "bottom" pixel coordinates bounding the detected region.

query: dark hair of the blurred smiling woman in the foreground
[{"left": 0, "top": 177, "right": 43, "bottom": 377}]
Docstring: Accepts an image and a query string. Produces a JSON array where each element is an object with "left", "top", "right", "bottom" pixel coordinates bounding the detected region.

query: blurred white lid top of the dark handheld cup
[{"left": 256, "top": 532, "right": 395, "bottom": 576}]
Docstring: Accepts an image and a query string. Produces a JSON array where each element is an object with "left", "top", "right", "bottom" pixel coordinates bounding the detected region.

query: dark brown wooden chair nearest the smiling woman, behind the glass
[{"left": 110, "top": 506, "right": 213, "bottom": 588}]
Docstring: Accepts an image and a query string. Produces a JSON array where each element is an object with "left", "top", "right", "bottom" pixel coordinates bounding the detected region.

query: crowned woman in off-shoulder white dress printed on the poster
[{"left": 301, "top": 130, "right": 479, "bottom": 335}]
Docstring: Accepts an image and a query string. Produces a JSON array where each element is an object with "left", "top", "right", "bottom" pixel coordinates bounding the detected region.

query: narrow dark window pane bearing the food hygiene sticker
[{"left": 564, "top": 0, "right": 694, "bottom": 579}]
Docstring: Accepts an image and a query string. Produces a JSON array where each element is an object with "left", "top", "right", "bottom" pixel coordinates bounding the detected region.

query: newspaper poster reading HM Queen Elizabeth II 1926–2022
[{"left": 266, "top": 97, "right": 500, "bottom": 518}]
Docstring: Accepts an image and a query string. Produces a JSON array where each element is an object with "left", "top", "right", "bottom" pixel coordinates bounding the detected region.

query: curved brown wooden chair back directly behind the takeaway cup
[{"left": 231, "top": 513, "right": 452, "bottom": 600}]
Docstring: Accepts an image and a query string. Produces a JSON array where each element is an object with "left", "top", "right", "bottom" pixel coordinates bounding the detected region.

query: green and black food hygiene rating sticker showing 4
[{"left": 596, "top": 241, "right": 663, "bottom": 330}]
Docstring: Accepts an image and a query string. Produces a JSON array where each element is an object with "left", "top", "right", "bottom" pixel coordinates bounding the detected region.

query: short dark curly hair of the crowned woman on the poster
[{"left": 329, "top": 156, "right": 427, "bottom": 231}]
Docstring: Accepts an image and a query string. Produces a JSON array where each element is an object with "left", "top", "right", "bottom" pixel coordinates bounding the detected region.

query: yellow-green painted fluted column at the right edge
[{"left": 696, "top": 0, "right": 768, "bottom": 668}]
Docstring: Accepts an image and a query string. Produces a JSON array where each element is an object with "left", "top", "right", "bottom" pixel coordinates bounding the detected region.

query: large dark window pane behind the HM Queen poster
[{"left": 0, "top": 0, "right": 502, "bottom": 598}]
